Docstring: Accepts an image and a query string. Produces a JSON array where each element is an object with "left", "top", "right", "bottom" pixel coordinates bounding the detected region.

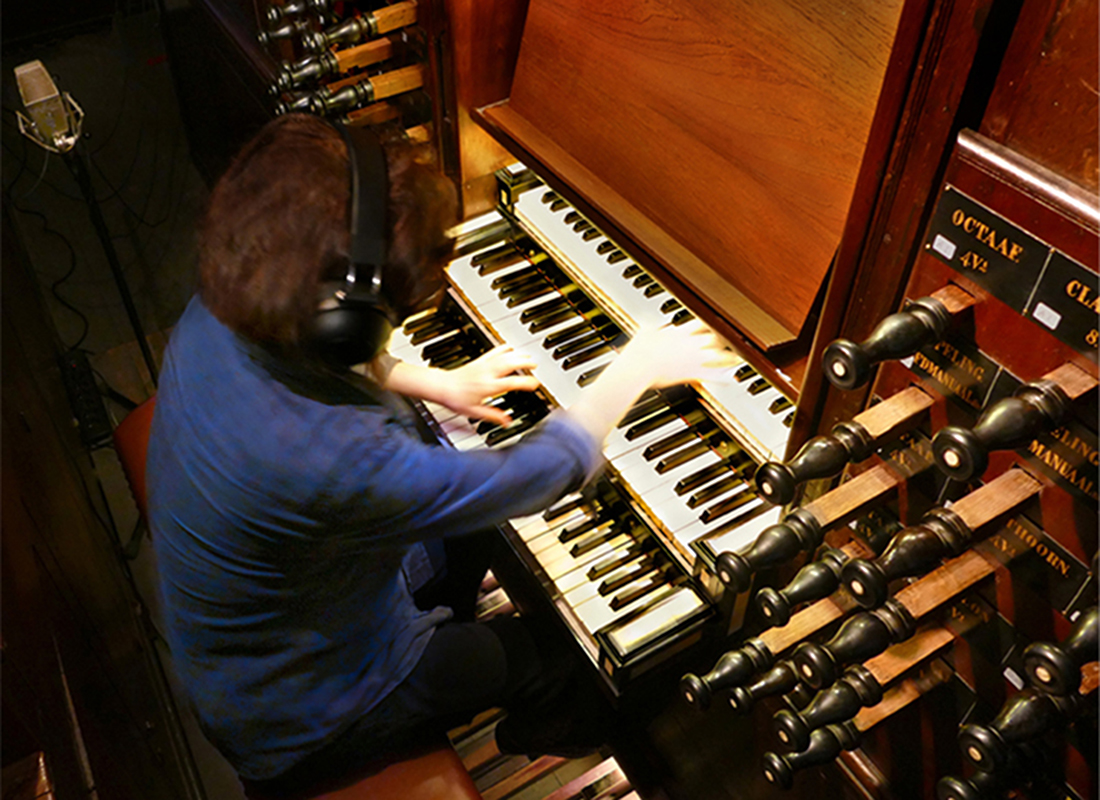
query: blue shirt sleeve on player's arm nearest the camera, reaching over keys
[{"left": 319, "top": 410, "right": 602, "bottom": 545}]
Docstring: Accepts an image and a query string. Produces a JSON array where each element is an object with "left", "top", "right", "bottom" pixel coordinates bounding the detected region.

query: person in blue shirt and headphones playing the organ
[{"left": 149, "top": 114, "right": 730, "bottom": 793}]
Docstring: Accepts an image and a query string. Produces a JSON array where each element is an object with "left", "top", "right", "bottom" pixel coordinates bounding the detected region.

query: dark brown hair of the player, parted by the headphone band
[{"left": 199, "top": 114, "right": 457, "bottom": 349}]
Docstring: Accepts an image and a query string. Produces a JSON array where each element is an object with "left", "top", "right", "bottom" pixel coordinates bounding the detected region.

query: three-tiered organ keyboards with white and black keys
[{"left": 378, "top": 203, "right": 793, "bottom": 690}]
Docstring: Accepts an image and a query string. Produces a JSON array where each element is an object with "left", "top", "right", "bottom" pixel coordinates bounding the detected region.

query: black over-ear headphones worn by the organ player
[{"left": 309, "top": 124, "right": 400, "bottom": 366}]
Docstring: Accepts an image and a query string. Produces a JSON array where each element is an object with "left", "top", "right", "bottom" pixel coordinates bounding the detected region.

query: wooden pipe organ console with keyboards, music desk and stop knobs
[{"left": 159, "top": 0, "right": 1100, "bottom": 800}]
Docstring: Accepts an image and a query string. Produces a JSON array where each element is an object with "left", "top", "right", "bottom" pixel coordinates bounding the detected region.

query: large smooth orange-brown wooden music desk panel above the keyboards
[{"left": 495, "top": 0, "right": 901, "bottom": 346}]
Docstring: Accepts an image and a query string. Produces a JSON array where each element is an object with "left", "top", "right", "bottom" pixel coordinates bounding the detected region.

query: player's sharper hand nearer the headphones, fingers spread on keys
[{"left": 435, "top": 344, "right": 539, "bottom": 425}]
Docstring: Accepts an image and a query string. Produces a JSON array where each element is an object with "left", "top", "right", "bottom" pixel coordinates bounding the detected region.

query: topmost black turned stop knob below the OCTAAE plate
[{"left": 822, "top": 297, "right": 950, "bottom": 390}]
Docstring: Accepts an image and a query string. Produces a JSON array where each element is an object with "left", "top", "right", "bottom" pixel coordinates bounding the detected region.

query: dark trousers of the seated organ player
[{"left": 245, "top": 531, "right": 575, "bottom": 798}]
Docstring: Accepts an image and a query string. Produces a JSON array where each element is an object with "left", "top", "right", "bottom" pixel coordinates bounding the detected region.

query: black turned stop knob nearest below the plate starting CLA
[{"left": 932, "top": 381, "right": 1069, "bottom": 481}]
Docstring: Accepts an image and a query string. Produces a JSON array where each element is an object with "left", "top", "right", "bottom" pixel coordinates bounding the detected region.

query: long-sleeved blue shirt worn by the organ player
[{"left": 147, "top": 298, "right": 598, "bottom": 779}]
